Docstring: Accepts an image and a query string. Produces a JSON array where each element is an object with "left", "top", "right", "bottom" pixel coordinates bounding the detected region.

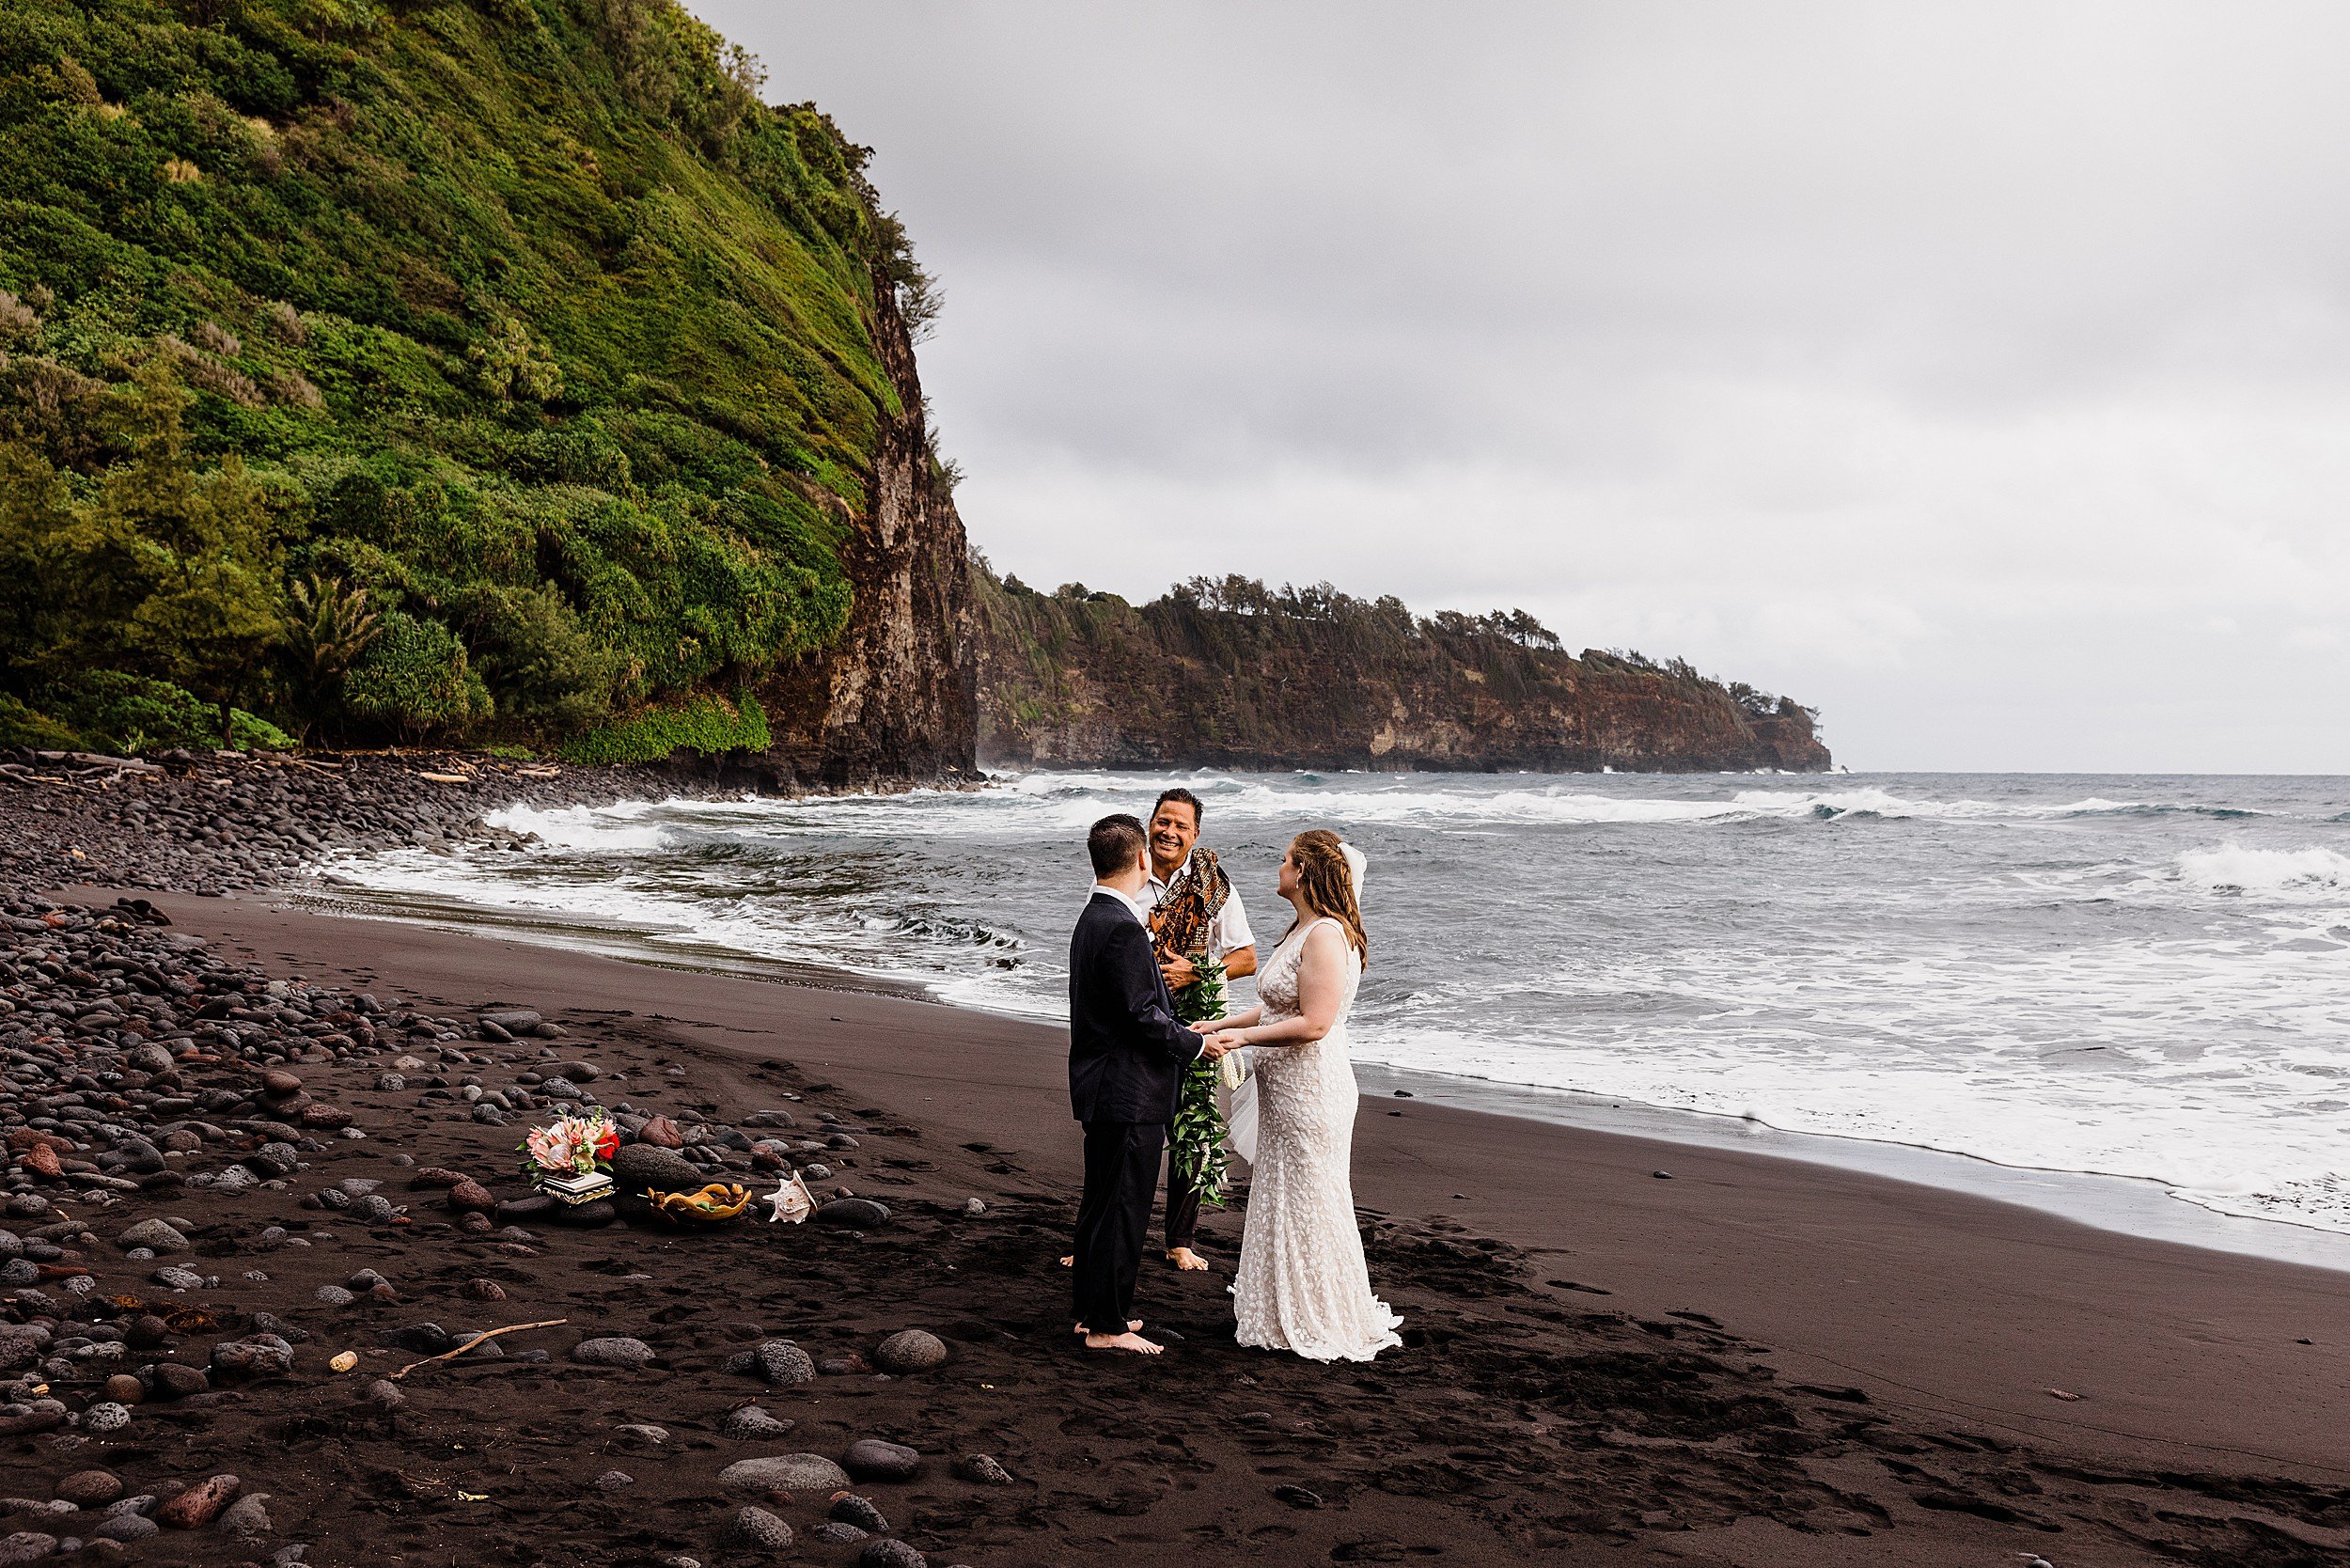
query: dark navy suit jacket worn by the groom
[{"left": 1070, "top": 893, "right": 1208, "bottom": 1123}]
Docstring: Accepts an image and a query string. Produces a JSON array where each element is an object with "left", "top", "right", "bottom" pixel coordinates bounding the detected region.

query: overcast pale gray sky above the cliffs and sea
[{"left": 694, "top": 0, "right": 2350, "bottom": 774}]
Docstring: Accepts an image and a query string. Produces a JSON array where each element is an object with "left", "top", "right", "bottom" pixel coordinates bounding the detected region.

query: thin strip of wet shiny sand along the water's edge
[{"left": 274, "top": 877, "right": 2350, "bottom": 1272}]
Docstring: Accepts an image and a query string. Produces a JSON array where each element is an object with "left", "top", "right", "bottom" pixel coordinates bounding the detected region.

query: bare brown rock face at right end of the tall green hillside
[{"left": 750, "top": 287, "right": 978, "bottom": 790}]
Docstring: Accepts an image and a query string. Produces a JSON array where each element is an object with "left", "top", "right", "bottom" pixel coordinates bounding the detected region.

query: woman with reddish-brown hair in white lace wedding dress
[{"left": 1201, "top": 830, "right": 1403, "bottom": 1361}]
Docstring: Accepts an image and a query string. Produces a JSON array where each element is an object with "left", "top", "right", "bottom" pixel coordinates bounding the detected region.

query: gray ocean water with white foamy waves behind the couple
[{"left": 324, "top": 774, "right": 2350, "bottom": 1231}]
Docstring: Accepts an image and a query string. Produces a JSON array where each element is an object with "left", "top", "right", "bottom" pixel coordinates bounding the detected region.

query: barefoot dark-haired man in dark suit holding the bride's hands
[{"left": 1070, "top": 813, "right": 1225, "bottom": 1356}]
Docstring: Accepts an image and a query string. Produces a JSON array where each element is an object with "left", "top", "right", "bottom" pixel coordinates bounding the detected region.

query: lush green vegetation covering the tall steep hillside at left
[{"left": 0, "top": 0, "right": 926, "bottom": 743}]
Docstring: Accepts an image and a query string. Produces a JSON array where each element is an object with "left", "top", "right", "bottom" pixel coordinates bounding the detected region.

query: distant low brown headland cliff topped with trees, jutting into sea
[{"left": 973, "top": 572, "right": 1828, "bottom": 774}]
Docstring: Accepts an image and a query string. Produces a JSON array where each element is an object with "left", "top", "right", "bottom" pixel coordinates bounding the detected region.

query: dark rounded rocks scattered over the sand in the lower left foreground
[{"left": 0, "top": 896, "right": 973, "bottom": 1563}]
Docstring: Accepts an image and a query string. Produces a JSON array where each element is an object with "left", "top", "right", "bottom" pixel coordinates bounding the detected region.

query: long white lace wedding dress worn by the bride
[{"left": 1231, "top": 921, "right": 1403, "bottom": 1361}]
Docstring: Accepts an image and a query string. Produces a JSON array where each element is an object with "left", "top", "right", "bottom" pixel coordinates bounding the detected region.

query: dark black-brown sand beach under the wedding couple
[{"left": 0, "top": 757, "right": 2350, "bottom": 1568}]
